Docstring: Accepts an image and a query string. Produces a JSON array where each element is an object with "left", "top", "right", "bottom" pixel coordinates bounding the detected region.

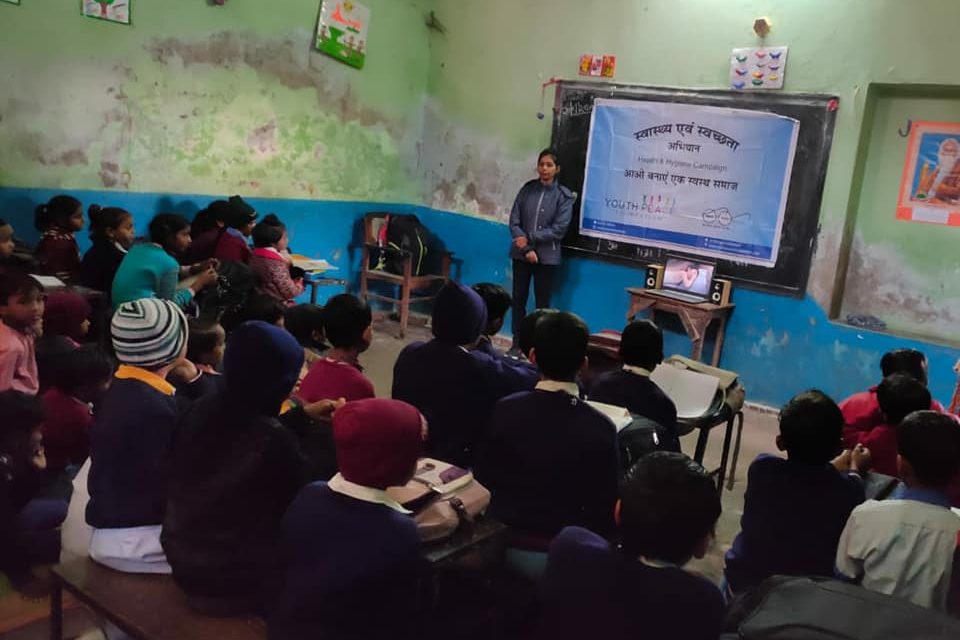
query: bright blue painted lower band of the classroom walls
[{"left": 0, "top": 188, "right": 960, "bottom": 406}]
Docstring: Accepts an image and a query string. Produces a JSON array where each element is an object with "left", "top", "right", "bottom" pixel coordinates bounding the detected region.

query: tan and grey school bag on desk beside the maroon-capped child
[{"left": 387, "top": 458, "right": 490, "bottom": 542}]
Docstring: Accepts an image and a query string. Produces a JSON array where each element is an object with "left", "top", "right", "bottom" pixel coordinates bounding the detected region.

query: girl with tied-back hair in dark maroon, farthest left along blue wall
[{"left": 33, "top": 195, "right": 83, "bottom": 283}]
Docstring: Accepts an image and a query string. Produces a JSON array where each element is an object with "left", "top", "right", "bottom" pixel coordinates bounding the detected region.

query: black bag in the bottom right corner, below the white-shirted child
[{"left": 721, "top": 576, "right": 960, "bottom": 640}]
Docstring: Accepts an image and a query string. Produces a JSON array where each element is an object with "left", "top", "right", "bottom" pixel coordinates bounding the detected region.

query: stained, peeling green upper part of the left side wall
[{"left": 0, "top": 0, "right": 430, "bottom": 202}]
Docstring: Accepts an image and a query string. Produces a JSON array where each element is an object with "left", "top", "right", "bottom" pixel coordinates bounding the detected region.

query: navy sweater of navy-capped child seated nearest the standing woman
[{"left": 393, "top": 340, "right": 538, "bottom": 467}]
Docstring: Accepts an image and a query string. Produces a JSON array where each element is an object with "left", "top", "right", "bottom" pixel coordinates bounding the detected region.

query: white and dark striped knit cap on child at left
[{"left": 110, "top": 298, "right": 187, "bottom": 369}]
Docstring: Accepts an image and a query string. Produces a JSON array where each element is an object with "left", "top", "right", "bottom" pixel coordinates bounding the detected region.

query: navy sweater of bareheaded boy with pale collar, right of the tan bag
[{"left": 477, "top": 390, "right": 620, "bottom": 537}]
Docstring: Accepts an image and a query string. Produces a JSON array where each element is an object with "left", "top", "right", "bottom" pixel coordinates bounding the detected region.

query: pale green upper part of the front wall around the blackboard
[{"left": 423, "top": 0, "right": 960, "bottom": 326}]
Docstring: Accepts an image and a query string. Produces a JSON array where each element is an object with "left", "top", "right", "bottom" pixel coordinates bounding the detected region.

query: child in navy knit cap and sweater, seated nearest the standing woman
[{"left": 393, "top": 282, "right": 537, "bottom": 467}]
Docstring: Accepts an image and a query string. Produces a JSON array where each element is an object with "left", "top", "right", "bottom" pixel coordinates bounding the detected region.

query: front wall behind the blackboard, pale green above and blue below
[{"left": 423, "top": 0, "right": 960, "bottom": 405}]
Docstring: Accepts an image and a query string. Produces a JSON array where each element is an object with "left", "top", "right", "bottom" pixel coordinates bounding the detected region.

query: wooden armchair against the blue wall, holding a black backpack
[{"left": 360, "top": 213, "right": 453, "bottom": 338}]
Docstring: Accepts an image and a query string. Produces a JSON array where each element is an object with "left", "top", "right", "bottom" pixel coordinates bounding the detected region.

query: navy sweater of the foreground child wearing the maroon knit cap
[{"left": 268, "top": 482, "right": 427, "bottom": 640}]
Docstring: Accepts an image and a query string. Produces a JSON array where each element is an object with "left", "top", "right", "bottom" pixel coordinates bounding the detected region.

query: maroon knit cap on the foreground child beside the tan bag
[{"left": 333, "top": 398, "right": 423, "bottom": 489}]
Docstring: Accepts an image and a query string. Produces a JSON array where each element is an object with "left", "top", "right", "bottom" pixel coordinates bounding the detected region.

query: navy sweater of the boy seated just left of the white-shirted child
[{"left": 726, "top": 454, "right": 864, "bottom": 591}]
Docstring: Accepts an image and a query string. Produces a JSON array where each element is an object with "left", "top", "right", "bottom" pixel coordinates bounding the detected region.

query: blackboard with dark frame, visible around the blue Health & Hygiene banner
[{"left": 552, "top": 81, "right": 838, "bottom": 297}]
